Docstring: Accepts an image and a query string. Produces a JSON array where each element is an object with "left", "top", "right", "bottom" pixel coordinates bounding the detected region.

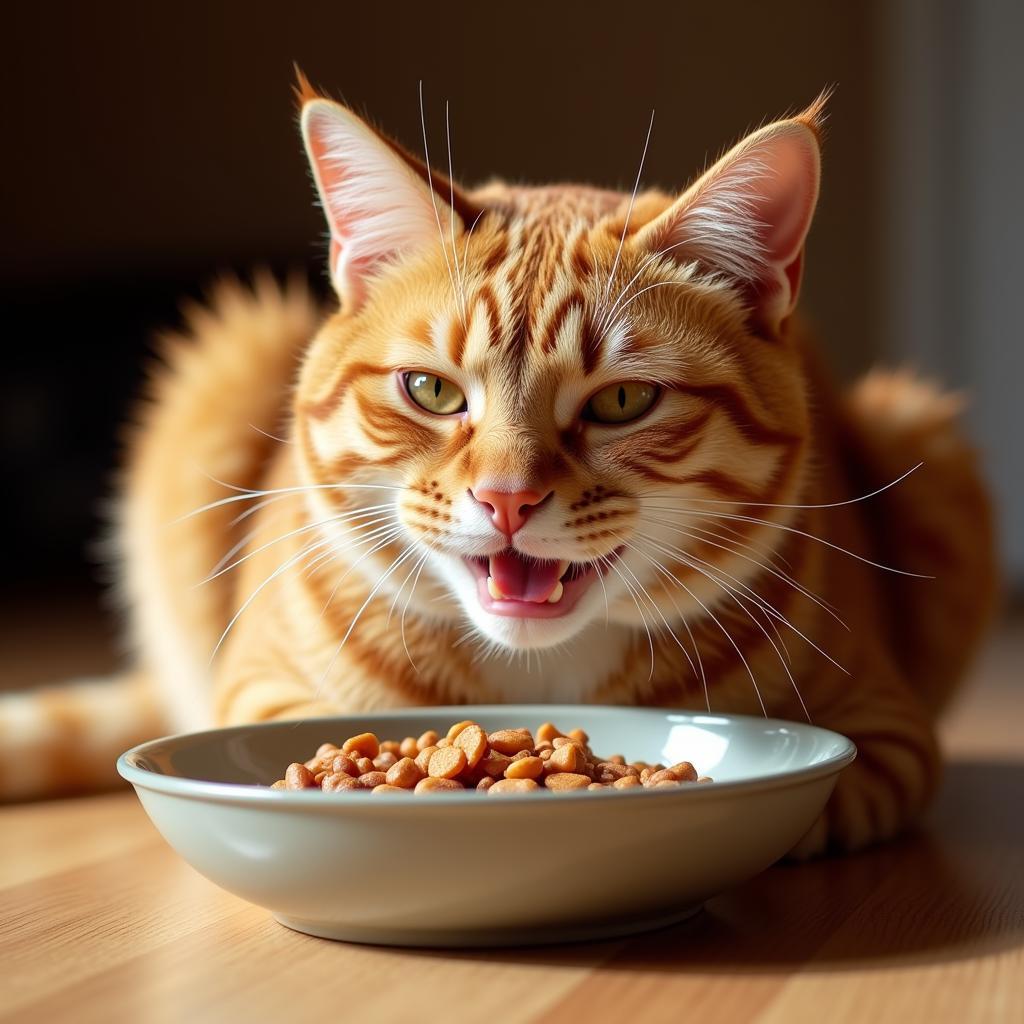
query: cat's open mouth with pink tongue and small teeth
[{"left": 465, "top": 548, "right": 618, "bottom": 618}]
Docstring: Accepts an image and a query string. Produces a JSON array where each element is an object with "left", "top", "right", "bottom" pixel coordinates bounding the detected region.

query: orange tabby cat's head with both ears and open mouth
[{"left": 295, "top": 79, "right": 821, "bottom": 649}]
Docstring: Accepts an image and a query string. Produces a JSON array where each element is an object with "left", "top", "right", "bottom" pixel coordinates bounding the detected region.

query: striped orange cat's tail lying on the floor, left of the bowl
[{"left": 0, "top": 673, "right": 166, "bottom": 803}]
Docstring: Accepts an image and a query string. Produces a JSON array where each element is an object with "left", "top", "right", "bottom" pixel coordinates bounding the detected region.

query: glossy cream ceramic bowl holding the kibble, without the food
[{"left": 118, "top": 705, "right": 856, "bottom": 946}]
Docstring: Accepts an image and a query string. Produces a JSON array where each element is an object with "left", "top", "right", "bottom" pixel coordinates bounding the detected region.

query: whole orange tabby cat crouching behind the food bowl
[{"left": 0, "top": 75, "right": 993, "bottom": 854}]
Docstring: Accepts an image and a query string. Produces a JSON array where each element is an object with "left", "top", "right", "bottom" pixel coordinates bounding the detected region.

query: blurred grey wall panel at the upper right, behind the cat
[{"left": 874, "top": 0, "right": 1024, "bottom": 589}]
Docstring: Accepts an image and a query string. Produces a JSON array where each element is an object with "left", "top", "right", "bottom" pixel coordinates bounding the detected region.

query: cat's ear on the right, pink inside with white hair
[{"left": 636, "top": 95, "right": 827, "bottom": 336}]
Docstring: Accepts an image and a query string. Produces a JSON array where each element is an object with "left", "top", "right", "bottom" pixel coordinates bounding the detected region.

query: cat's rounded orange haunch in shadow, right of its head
[{"left": 847, "top": 371, "right": 998, "bottom": 714}]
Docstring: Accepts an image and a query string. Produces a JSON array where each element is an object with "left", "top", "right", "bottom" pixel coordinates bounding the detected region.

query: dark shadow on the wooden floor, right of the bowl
[{"left": 409, "top": 762, "right": 1024, "bottom": 974}]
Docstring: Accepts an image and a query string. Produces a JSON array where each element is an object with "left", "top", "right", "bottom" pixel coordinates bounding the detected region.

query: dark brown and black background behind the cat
[{"left": 0, "top": 0, "right": 1024, "bottom": 630}]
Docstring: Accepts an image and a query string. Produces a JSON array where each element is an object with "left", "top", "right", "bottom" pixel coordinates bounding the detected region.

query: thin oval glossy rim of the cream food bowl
[{"left": 117, "top": 705, "right": 857, "bottom": 810}]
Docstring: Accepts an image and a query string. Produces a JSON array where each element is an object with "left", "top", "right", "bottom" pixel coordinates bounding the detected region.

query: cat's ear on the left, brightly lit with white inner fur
[{"left": 300, "top": 79, "right": 462, "bottom": 311}]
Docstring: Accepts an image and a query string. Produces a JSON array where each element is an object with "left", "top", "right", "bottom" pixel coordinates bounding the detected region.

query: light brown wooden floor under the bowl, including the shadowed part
[{"left": 0, "top": 598, "right": 1024, "bottom": 1024}]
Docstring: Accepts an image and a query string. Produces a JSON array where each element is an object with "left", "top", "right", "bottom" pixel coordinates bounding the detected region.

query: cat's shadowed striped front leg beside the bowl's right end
[{"left": 790, "top": 666, "right": 941, "bottom": 860}]
